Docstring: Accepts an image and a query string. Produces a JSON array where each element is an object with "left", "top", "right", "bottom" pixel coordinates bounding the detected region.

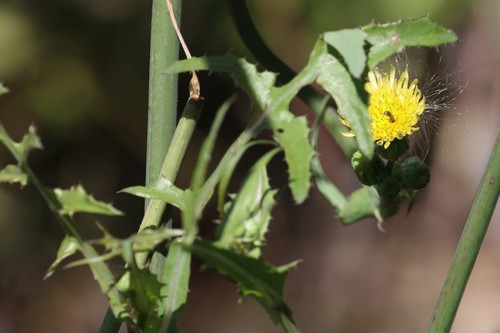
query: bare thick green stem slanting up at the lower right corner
[{"left": 427, "top": 136, "right": 500, "bottom": 333}]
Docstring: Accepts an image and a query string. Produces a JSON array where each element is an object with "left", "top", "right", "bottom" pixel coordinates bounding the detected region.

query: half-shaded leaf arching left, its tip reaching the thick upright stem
[{"left": 168, "top": 53, "right": 276, "bottom": 110}]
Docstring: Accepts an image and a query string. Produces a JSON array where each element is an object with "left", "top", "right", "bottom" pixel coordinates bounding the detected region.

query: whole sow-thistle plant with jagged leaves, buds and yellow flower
[{"left": 0, "top": 5, "right": 464, "bottom": 333}]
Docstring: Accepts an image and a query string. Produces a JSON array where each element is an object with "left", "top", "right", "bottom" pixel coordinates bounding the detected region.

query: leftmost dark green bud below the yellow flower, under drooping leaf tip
[{"left": 351, "top": 151, "right": 386, "bottom": 186}]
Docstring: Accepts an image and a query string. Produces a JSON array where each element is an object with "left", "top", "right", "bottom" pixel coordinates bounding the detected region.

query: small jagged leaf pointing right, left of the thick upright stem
[{"left": 51, "top": 185, "right": 123, "bottom": 216}]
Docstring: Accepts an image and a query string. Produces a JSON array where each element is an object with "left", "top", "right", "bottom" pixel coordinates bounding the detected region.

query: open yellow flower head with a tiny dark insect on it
[{"left": 365, "top": 68, "right": 425, "bottom": 149}]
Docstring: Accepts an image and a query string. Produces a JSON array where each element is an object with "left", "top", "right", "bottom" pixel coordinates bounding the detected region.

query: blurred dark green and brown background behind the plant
[{"left": 0, "top": 0, "right": 500, "bottom": 333}]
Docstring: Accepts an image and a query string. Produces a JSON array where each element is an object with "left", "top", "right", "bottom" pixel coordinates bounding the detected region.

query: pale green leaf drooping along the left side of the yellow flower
[{"left": 315, "top": 39, "right": 374, "bottom": 158}]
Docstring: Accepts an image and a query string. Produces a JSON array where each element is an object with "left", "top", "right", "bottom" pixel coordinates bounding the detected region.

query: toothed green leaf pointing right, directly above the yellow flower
[{"left": 362, "top": 17, "right": 458, "bottom": 68}]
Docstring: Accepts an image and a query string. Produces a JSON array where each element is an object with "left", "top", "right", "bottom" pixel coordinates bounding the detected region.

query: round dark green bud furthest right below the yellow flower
[{"left": 392, "top": 156, "right": 431, "bottom": 190}]
